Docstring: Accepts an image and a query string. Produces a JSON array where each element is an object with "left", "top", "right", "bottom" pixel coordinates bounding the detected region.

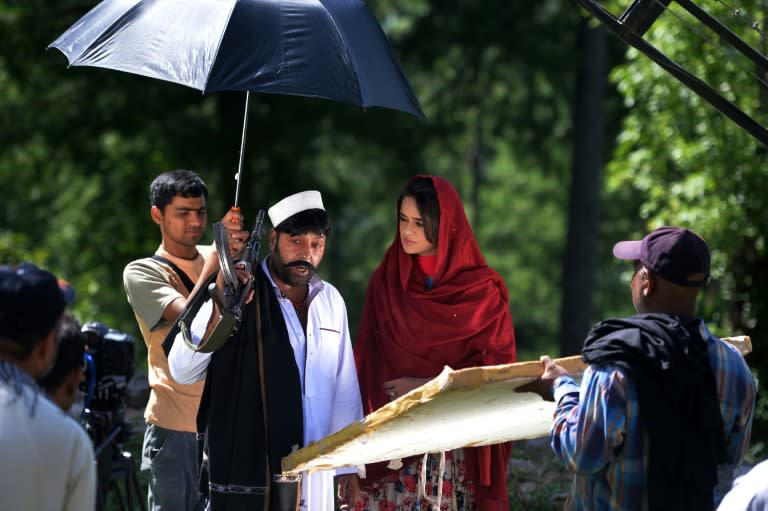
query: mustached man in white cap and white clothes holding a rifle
[{"left": 168, "top": 191, "right": 363, "bottom": 511}]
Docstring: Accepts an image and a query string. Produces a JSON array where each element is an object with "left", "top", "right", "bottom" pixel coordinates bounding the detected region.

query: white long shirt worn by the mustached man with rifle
[{"left": 168, "top": 259, "right": 363, "bottom": 511}]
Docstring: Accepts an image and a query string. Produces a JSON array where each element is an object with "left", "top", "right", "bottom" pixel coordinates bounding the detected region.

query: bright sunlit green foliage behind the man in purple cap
[{"left": 606, "top": 1, "right": 768, "bottom": 456}]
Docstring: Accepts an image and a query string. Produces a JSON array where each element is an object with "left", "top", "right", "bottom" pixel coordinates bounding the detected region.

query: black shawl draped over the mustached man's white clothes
[{"left": 198, "top": 271, "right": 304, "bottom": 511}]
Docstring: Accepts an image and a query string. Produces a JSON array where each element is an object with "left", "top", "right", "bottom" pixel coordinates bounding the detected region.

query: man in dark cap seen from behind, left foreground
[{"left": 0, "top": 263, "right": 96, "bottom": 511}]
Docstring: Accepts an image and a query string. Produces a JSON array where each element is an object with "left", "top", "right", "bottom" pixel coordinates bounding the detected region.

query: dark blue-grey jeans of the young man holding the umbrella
[{"left": 141, "top": 424, "right": 202, "bottom": 511}]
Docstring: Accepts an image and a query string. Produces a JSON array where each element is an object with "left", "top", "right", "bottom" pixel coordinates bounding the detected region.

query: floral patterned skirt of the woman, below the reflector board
[{"left": 355, "top": 449, "right": 477, "bottom": 511}]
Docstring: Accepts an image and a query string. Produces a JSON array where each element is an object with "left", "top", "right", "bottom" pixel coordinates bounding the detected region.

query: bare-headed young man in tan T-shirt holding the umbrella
[{"left": 123, "top": 169, "right": 248, "bottom": 511}]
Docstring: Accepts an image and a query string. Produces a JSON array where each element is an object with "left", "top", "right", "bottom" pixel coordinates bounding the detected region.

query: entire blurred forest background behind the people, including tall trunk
[{"left": 0, "top": 0, "right": 768, "bottom": 492}]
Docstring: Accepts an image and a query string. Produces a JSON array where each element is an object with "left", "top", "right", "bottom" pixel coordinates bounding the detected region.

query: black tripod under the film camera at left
[{"left": 95, "top": 422, "right": 147, "bottom": 511}]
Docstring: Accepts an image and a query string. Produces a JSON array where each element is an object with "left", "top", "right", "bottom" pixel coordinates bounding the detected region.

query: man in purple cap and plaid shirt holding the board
[{"left": 521, "top": 227, "right": 755, "bottom": 511}]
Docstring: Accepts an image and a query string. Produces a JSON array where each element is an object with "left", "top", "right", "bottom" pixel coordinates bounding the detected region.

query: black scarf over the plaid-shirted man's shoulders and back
[{"left": 582, "top": 314, "right": 725, "bottom": 511}]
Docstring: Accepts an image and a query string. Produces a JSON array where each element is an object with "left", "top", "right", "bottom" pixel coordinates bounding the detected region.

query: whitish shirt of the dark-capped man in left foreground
[{"left": 0, "top": 361, "right": 96, "bottom": 511}]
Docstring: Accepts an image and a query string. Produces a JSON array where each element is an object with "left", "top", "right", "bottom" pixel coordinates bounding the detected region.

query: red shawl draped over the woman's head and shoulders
[{"left": 355, "top": 176, "right": 516, "bottom": 511}]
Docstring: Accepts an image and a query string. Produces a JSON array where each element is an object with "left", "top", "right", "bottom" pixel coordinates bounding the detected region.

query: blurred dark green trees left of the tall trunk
[{"left": 0, "top": 0, "right": 577, "bottom": 356}]
